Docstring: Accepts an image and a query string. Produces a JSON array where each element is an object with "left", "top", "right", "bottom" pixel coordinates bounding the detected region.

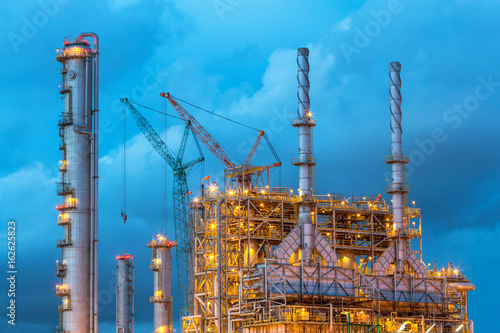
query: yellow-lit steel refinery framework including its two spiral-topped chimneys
[{"left": 182, "top": 49, "right": 474, "bottom": 333}]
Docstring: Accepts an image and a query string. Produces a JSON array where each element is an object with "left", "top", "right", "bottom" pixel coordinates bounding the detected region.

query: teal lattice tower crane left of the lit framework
[{"left": 121, "top": 98, "right": 204, "bottom": 318}]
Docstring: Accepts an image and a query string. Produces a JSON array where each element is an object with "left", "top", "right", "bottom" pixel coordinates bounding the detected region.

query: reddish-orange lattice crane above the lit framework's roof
[{"left": 160, "top": 92, "right": 281, "bottom": 184}]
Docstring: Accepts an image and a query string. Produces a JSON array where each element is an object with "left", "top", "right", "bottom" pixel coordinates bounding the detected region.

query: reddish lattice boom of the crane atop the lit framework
[{"left": 160, "top": 93, "right": 236, "bottom": 168}]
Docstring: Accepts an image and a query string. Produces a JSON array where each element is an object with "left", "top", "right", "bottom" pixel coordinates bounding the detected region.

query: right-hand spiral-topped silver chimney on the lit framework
[{"left": 386, "top": 62, "right": 408, "bottom": 273}]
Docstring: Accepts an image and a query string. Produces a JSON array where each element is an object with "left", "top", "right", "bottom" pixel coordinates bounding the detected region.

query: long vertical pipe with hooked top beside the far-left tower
[{"left": 77, "top": 32, "right": 99, "bottom": 333}]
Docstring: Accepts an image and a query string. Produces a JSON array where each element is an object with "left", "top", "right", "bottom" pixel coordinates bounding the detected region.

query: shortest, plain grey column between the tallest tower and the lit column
[{"left": 116, "top": 254, "right": 134, "bottom": 333}]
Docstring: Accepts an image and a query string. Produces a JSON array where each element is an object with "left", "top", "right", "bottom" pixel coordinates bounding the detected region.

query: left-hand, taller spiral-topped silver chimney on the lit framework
[{"left": 292, "top": 48, "right": 316, "bottom": 261}]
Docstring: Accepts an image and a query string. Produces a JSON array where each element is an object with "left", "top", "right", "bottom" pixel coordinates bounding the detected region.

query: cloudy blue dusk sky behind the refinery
[{"left": 0, "top": 0, "right": 500, "bottom": 332}]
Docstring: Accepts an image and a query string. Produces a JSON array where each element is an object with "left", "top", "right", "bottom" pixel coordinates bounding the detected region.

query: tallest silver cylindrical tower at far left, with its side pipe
[{"left": 56, "top": 34, "right": 98, "bottom": 333}]
